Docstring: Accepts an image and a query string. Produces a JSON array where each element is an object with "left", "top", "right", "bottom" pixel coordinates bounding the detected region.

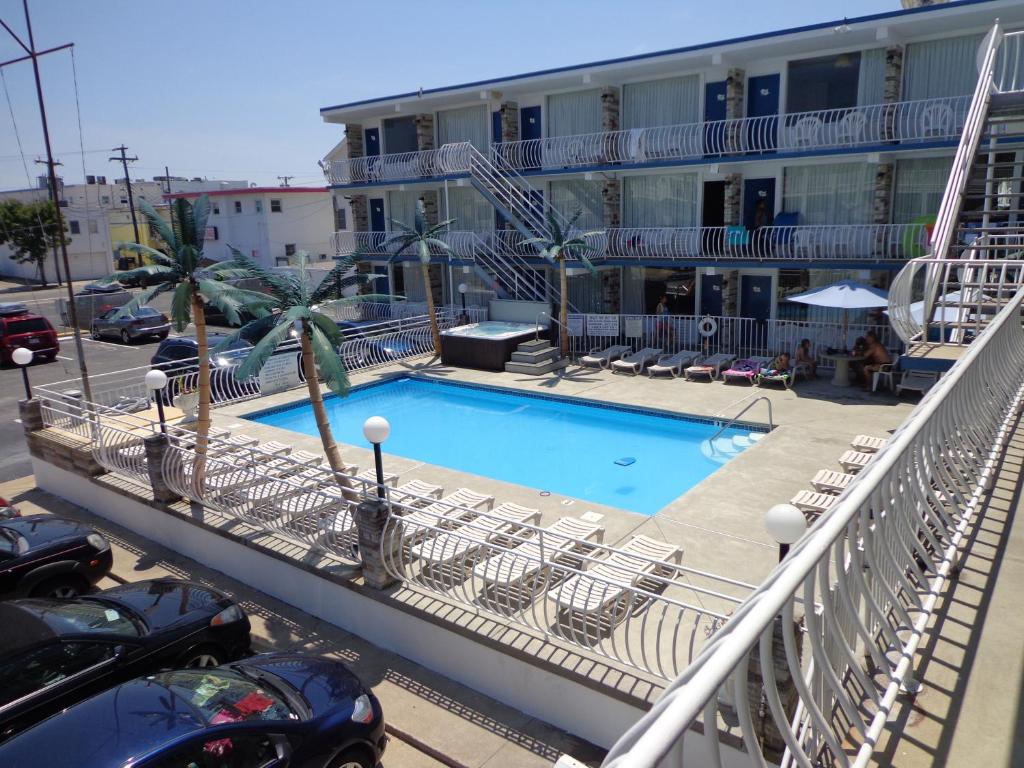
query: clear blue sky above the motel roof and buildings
[{"left": 0, "top": 0, "right": 899, "bottom": 189}]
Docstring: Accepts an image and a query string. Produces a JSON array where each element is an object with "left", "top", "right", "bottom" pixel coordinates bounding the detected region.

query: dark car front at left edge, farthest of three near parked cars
[{"left": 0, "top": 515, "right": 113, "bottom": 602}]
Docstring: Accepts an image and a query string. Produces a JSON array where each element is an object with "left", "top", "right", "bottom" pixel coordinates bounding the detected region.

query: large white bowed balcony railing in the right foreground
[{"left": 604, "top": 291, "right": 1024, "bottom": 768}]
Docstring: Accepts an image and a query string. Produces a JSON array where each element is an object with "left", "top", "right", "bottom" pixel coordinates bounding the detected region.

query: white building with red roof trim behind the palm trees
[{"left": 164, "top": 186, "right": 335, "bottom": 268}]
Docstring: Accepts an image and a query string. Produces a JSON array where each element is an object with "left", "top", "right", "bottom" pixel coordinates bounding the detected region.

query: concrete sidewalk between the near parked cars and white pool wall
[{"left": 0, "top": 477, "right": 603, "bottom": 768}]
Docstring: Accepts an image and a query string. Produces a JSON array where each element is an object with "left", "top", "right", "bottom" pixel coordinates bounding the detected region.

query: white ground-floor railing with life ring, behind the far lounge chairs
[{"left": 569, "top": 314, "right": 900, "bottom": 368}]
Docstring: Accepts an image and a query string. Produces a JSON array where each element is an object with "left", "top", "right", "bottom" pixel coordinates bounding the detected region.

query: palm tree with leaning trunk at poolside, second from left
[{"left": 218, "top": 248, "right": 391, "bottom": 487}]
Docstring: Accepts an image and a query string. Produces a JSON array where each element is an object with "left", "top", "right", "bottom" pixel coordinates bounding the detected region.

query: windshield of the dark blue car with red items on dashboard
[{"left": 153, "top": 668, "right": 299, "bottom": 725}]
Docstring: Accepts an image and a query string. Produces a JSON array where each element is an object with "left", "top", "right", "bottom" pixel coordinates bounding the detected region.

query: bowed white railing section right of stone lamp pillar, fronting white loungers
[{"left": 382, "top": 512, "right": 752, "bottom": 680}]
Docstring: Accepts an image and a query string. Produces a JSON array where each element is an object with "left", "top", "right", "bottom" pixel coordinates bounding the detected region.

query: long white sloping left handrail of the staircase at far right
[{"left": 921, "top": 20, "right": 1002, "bottom": 339}]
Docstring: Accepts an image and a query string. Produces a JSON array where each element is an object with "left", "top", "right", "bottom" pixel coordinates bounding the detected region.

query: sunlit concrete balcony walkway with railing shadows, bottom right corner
[{"left": 874, "top": 415, "right": 1024, "bottom": 768}]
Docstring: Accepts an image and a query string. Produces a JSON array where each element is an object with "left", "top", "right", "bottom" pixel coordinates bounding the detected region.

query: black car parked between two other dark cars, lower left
[{"left": 0, "top": 579, "right": 250, "bottom": 741}]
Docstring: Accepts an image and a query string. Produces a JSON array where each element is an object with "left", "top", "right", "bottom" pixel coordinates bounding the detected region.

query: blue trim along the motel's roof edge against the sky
[{"left": 319, "top": 0, "right": 995, "bottom": 115}]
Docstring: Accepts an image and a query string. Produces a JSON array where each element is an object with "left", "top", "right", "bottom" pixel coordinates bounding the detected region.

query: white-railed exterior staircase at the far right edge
[{"left": 889, "top": 25, "right": 1024, "bottom": 371}]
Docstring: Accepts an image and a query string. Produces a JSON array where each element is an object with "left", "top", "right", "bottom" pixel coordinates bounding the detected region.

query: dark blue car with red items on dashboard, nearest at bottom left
[{"left": 0, "top": 653, "right": 387, "bottom": 768}]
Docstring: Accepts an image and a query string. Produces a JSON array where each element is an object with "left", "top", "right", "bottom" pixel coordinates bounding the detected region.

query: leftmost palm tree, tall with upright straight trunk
[{"left": 108, "top": 195, "right": 271, "bottom": 456}]
